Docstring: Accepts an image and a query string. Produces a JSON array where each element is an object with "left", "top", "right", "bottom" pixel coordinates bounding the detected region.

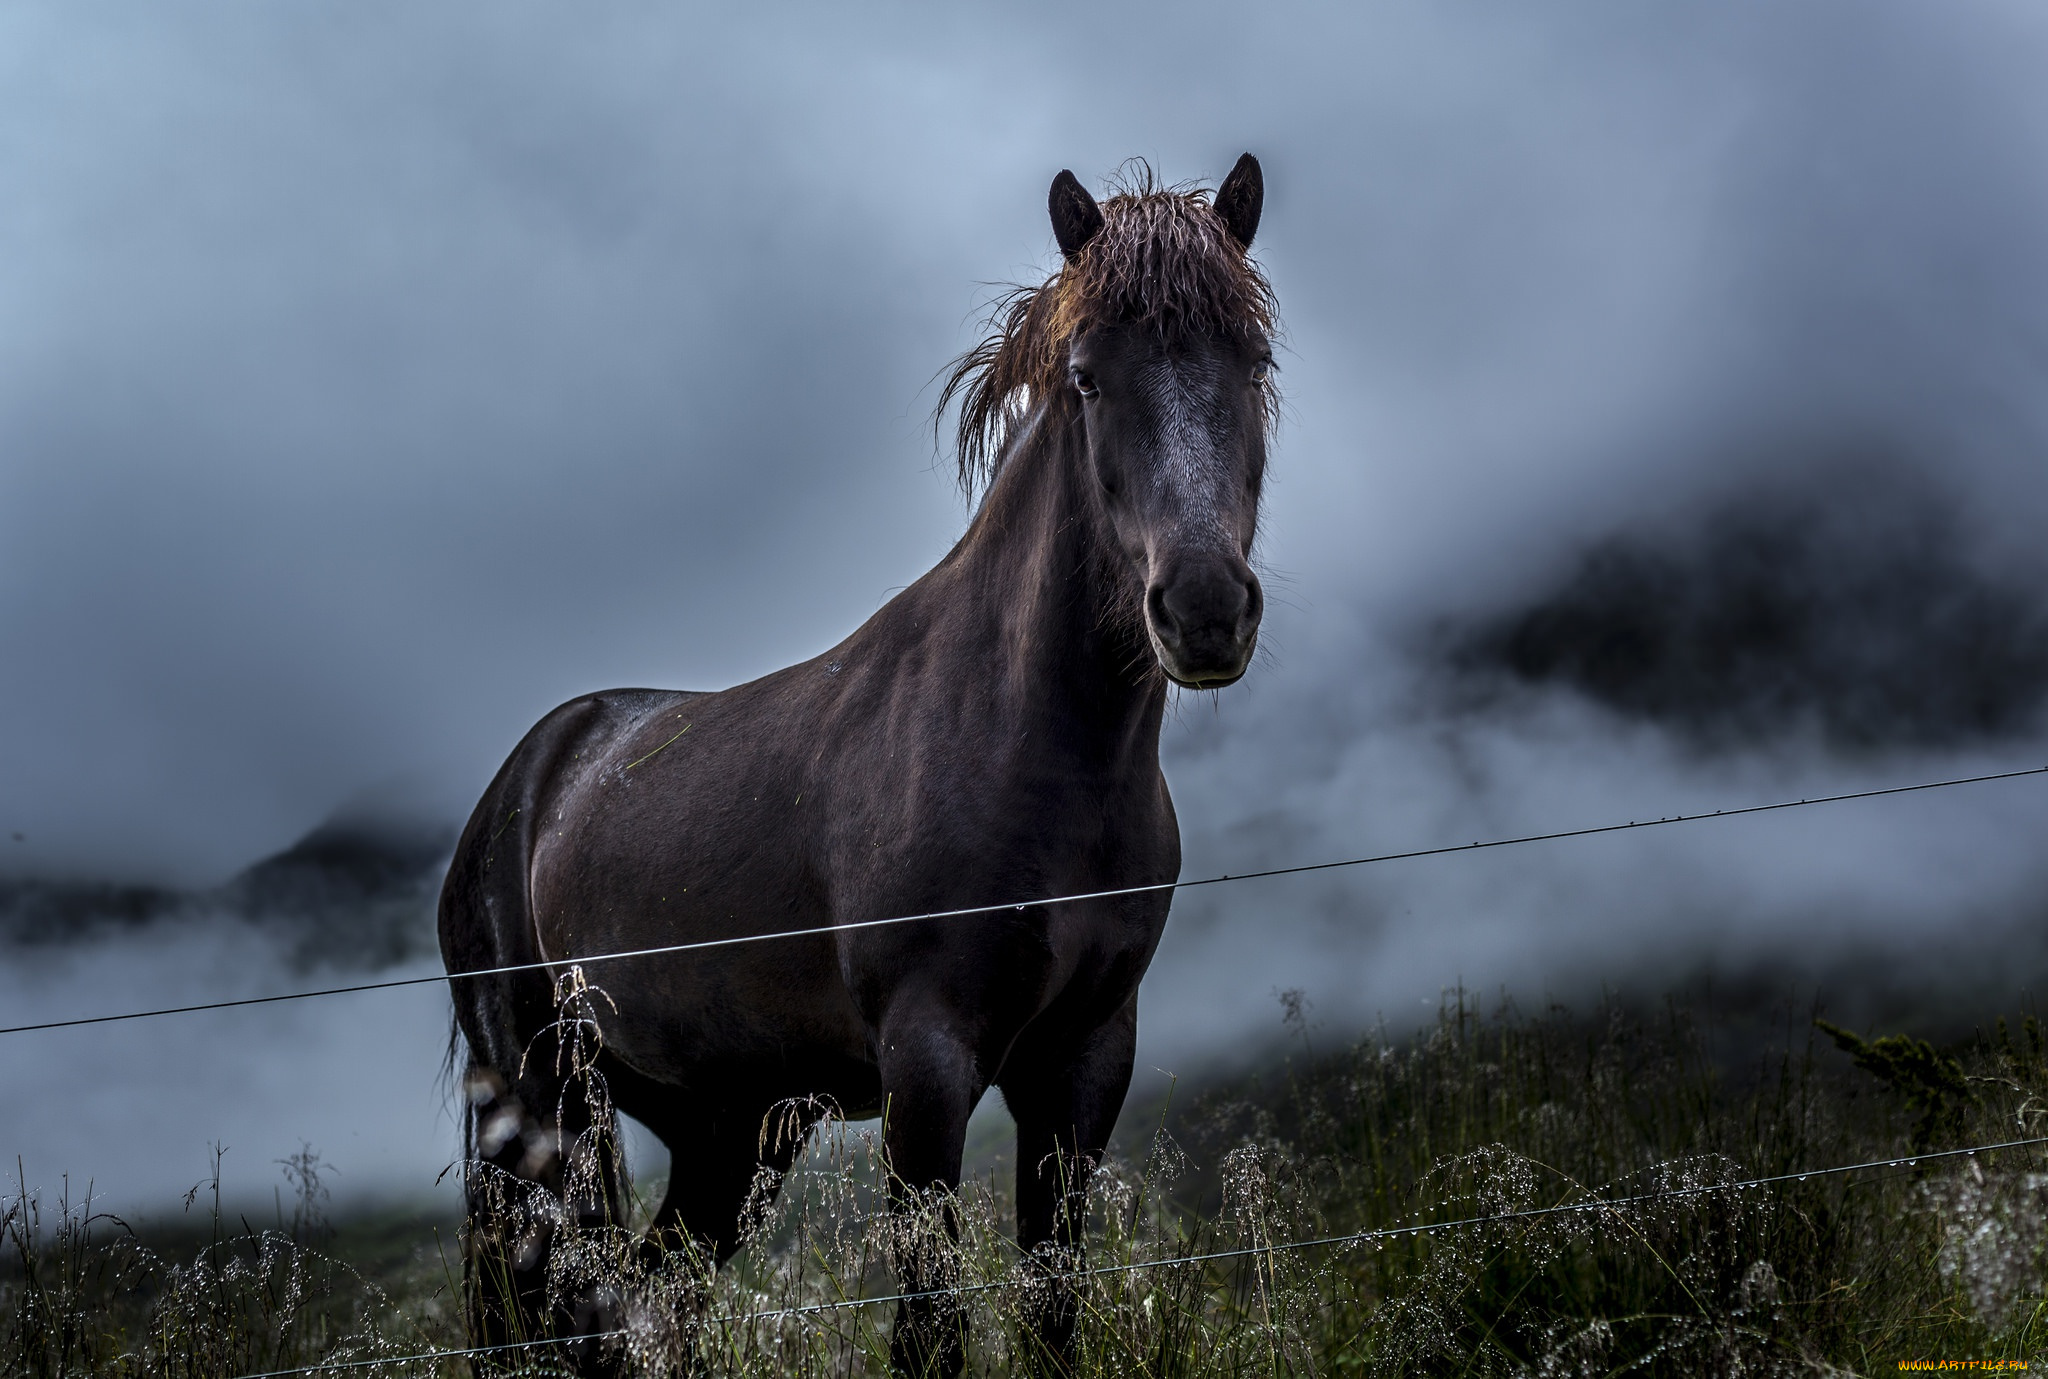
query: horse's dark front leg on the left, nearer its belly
[{"left": 879, "top": 1014, "right": 987, "bottom": 1379}]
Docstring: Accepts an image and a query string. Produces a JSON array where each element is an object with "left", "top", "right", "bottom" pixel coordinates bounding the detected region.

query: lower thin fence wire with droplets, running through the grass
[{"left": 220, "top": 1135, "right": 2048, "bottom": 1379}]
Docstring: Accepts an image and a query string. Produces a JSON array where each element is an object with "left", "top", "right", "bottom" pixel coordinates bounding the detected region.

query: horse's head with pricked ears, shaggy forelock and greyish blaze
[{"left": 948, "top": 154, "right": 1276, "bottom": 688}]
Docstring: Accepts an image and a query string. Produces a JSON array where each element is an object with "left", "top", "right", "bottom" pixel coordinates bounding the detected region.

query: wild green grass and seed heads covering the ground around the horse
[{"left": 0, "top": 996, "right": 2048, "bottom": 1379}]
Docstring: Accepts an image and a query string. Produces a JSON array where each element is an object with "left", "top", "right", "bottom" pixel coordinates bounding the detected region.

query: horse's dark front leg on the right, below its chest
[{"left": 1001, "top": 1002, "right": 1137, "bottom": 1373}]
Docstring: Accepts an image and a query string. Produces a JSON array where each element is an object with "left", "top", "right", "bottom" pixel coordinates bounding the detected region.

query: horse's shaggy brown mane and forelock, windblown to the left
[{"left": 934, "top": 160, "right": 1278, "bottom": 494}]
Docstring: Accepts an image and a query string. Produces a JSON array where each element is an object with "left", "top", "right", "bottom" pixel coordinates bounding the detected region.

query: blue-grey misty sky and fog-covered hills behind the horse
[{"left": 0, "top": 0, "right": 2048, "bottom": 1207}]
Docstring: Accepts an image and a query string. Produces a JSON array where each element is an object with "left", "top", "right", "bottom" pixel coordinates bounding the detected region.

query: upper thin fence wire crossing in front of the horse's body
[{"left": 0, "top": 766, "right": 2048, "bottom": 1035}]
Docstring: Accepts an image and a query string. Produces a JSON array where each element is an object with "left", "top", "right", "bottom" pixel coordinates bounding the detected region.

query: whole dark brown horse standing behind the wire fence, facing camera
[{"left": 440, "top": 154, "right": 1274, "bottom": 1373}]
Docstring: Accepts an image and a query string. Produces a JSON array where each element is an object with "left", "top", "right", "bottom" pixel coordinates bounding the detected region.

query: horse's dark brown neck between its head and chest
[{"left": 958, "top": 403, "right": 1165, "bottom": 756}]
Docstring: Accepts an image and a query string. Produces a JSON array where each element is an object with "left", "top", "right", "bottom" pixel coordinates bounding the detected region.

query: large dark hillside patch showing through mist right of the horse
[{"left": 1438, "top": 459, "right": 2048, "bottom": 752}]
